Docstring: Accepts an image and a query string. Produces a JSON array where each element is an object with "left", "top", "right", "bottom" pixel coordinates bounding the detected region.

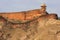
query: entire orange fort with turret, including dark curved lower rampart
[{"left": 0, "top": 4, "right": 58, "bottom": 27}]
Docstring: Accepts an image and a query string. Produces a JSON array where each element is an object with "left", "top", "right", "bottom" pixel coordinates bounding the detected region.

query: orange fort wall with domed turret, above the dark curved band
[{"left": 0, "top": 4, "right": 58, "bottom": 21}]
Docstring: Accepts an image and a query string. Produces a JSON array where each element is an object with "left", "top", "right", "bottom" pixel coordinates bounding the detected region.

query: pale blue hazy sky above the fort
[{"left": 0, "top": 0, "right": 60, "bottom": 17}]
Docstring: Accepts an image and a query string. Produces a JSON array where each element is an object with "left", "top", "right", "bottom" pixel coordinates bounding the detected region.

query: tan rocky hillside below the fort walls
[{"left": 0, "top": 19, "right": 60, "bottom": 40}]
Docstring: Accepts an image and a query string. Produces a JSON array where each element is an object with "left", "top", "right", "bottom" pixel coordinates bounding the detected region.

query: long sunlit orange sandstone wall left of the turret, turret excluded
[{"left": 0, "top": 9, "right": 46, "bottom": 20}]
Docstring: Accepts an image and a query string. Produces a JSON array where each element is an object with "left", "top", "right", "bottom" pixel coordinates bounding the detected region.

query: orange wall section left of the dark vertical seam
[{"left": 0, "top": 13, "right": 24, "bottom": 20}]
